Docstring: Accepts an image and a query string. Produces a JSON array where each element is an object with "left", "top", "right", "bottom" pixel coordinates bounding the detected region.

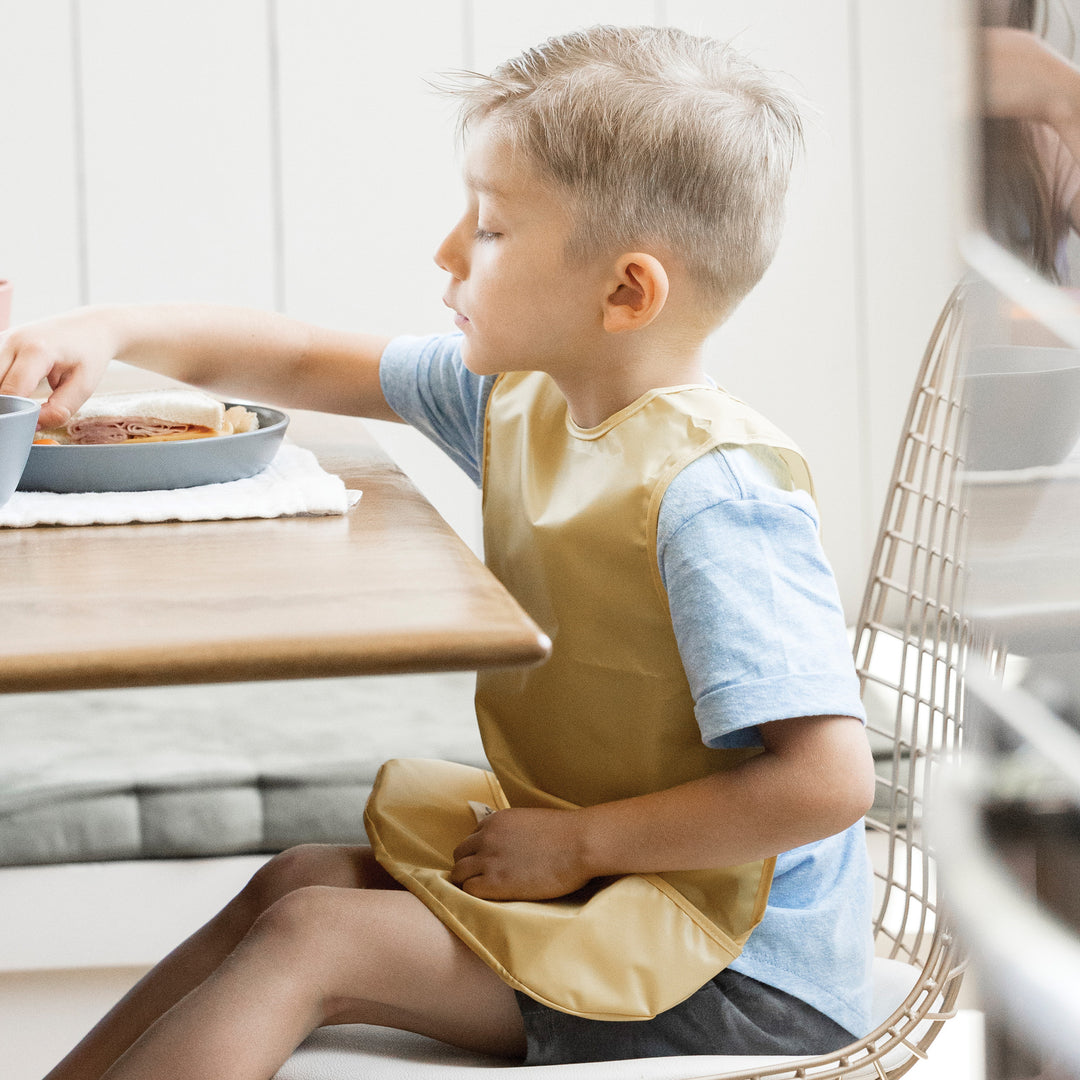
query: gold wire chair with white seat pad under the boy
[{"left": 279, "top": 288, "right": 972, "bottom": 1080}]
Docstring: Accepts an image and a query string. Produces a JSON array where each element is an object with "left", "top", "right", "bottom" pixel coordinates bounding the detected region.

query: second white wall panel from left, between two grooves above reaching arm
[{"left": 81, "top": 0, "right": 273, "bottom": 307}]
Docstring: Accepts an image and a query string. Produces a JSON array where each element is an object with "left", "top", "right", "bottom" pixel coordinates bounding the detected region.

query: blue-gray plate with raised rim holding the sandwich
[{"left": 18, "top": 402, "right": 288, "bottom": 492}]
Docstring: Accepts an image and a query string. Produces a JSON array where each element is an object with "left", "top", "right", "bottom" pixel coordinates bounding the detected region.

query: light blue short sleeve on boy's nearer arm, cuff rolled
[{"left": 657, "top": 447, "right": 865, "bottom": 747}]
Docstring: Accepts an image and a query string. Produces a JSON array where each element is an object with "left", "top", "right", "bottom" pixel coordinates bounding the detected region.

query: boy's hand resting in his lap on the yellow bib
[{"left": 450, "top": 808, "right": 593, "bottom": 900}]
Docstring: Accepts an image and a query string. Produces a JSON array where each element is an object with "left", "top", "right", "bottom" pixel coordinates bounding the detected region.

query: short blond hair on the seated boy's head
[{"left": 448, "top": 26, "right": 802, "bottom": 312}]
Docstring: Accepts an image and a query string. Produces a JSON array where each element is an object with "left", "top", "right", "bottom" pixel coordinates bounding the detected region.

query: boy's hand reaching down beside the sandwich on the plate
[{"left": 0, "top": 308, "right": 117, "bottom": 428}]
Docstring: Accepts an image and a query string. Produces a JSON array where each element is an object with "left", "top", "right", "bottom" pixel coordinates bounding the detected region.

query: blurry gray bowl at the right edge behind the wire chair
[{"left": 963, "top": 345, "right": 1080, "bottom": 471}]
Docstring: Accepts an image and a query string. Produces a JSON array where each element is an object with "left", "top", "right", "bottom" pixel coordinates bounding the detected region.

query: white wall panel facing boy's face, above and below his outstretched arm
[{"left": 278, "top": 0, "right": 481, "bottom": 550}]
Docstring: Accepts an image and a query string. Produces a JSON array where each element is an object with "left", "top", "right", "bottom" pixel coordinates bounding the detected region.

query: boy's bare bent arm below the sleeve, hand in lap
[{"left": 451, "top": 716, "right": 874, "bottom": 900}]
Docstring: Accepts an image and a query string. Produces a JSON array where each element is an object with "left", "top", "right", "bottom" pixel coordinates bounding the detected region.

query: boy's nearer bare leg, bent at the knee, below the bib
[{"left": 95, "top": 886, "right": 525, "bottom": 1080}]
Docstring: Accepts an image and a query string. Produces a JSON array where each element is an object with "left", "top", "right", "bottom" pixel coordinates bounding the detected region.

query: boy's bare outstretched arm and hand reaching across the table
[{"left": 0, "top": 305, "right": 397, "bottom": 427}]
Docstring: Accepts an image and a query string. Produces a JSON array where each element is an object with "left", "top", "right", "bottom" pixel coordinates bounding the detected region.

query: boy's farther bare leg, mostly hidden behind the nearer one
[{"left": 46, "top": 845, "right": 481, "bottom": 1080}]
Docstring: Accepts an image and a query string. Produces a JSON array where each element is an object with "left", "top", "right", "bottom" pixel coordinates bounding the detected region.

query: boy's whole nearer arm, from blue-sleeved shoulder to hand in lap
[{"left": 454, "top": 450, "right": 874, "bottom": 899}]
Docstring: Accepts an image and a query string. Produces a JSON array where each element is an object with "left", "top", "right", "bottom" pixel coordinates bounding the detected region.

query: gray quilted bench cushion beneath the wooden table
[{"left": 0, "top": 673, "right": 484, "bottom": 865}]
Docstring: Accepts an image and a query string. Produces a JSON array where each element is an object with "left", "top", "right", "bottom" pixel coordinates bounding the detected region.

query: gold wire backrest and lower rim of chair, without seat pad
[{"left": 708, "top": 287, "right": 973, "bottom": 1080}]
